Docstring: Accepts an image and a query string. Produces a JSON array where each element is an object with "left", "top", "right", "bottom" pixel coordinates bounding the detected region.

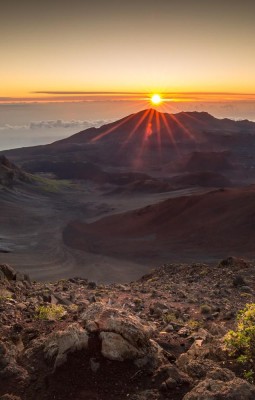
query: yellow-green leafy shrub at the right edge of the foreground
[{"left": 224, "top": 303, "right": 255, "bottom": 382}]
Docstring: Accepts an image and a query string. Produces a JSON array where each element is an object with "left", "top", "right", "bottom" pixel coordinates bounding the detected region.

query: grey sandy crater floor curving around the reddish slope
[{"left": 0, "top": 178, "right": 211, "bottom": 282}]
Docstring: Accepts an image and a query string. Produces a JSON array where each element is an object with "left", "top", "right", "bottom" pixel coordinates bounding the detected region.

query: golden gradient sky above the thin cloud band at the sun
[{"left": 0, "top": 0, "right": 255, "bottom": 101}]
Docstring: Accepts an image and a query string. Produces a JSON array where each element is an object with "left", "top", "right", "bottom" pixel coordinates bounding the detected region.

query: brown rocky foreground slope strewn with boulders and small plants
[{"left": 0, "top": 258, "right": 255, "bottom": 400}]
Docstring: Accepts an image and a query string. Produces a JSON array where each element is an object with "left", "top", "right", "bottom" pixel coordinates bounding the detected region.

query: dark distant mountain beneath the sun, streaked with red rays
[{"left": 0, "top": 109, "right": 255, "bottom": 179}]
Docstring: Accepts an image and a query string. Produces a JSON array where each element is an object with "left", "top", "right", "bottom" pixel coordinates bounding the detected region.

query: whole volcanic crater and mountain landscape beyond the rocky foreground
[{"left": 0, "top": 109, "right": 255, "bottom": 282}]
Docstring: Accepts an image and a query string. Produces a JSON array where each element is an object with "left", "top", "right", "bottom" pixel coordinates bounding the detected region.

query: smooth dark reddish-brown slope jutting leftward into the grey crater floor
[{"left": 63, "top": 187, "right": 255, "bottom": 264}]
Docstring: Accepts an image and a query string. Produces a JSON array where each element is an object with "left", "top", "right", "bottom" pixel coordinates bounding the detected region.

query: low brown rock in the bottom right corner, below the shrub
[{"left": 183, "top": 378, "right": 255, "bottom": 400}]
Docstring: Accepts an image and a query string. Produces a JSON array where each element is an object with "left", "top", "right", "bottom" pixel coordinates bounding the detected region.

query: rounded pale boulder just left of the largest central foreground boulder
[{"left": 44, "top": 324, "right": 89, "bottom": 370}]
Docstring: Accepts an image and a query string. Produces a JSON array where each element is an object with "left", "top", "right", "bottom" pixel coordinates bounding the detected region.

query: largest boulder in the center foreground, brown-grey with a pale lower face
[{"left": 82, "top": 303, "right": 162, "bottom": 368}]
